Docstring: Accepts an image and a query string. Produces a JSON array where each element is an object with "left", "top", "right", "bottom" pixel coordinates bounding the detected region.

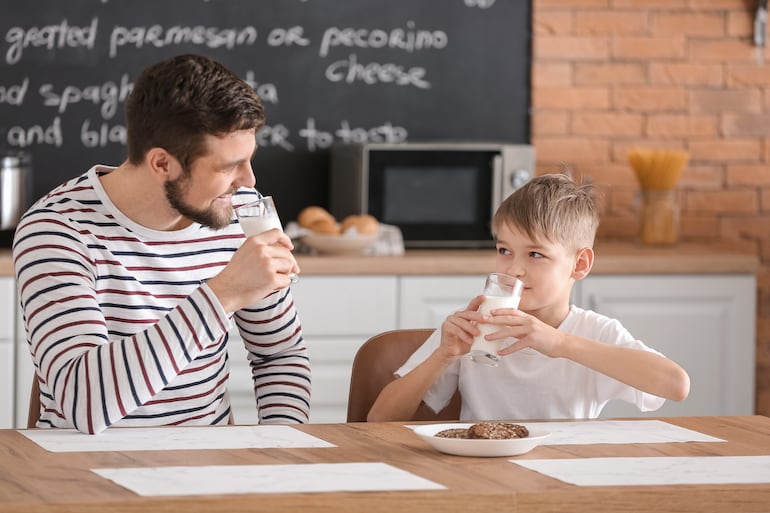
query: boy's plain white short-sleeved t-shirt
[{"left": 395, "top": 306, "right": 665, "bottom": 421}]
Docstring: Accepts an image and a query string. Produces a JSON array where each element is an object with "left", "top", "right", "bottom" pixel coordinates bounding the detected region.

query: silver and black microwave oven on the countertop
[{"left": 329, "top": 142, "right": 535, "bottom": 248}]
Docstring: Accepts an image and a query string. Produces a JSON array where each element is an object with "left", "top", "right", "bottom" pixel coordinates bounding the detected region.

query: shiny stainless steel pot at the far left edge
[{"left": 0, "top": 151, "right": 32, "bottom": 230}]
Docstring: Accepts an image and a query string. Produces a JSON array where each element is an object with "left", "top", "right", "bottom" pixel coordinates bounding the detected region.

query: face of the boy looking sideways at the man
[{"left": 496, "top": 224, "right": 577, "bottom": 323}]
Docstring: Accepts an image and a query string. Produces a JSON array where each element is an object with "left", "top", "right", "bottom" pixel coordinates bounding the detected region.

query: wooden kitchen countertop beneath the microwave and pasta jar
[{"left": 0, "top": 242, "right": 759, "bottom": 276}]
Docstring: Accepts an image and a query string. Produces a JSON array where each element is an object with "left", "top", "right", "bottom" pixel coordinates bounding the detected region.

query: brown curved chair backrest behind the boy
[{"left": 348, "top": 329, "right": 460, "bottom": 422}]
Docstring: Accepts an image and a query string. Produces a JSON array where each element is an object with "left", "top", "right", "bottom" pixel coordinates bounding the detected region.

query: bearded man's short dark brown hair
[{"left": 126, "top": 55, "right": 265, "bottom": 168}]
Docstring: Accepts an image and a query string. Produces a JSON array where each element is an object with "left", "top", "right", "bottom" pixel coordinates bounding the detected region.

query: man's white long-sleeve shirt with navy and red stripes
[{"left": 13, "top": 166, "right": 310, "bottom": 433}]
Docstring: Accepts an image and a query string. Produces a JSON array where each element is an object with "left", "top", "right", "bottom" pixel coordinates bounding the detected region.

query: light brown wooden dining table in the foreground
[{"left": 0, "top": 416, "right": 770, "bottom": 513}]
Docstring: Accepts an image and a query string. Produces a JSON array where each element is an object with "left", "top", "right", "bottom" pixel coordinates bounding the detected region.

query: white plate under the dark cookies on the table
[{"left": 413, "top": 423, "right": 551, "bottom": 457}]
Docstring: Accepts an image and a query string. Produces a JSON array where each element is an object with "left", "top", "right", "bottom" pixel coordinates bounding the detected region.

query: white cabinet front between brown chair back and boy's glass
[{"left": 399, "top": 276, "right": 484, "bottom": 328}]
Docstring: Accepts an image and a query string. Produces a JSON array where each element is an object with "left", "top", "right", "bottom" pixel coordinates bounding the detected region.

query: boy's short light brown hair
[{"left": 492, "top": 174, "right": 599, "bottom": 250}]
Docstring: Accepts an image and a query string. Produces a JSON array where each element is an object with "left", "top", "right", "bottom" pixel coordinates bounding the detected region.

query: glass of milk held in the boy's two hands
[{"left": 468, "top": 273, "right": 524, "bottom": 367}]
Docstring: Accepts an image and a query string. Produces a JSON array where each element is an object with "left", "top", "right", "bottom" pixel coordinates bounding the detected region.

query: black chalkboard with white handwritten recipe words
[{"left": 0, "top": 0, "right": 531, "bottom": 219}]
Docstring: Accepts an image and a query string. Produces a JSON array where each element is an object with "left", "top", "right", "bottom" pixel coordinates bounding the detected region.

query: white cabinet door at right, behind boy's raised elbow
[{"left": 577, "top": 275, "right": 756, "bottom": 417}]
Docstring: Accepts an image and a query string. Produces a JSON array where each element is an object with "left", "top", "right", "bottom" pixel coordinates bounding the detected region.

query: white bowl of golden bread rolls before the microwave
[{"left": 297, "top": 205, "right": 380, "bottom": 255}]
